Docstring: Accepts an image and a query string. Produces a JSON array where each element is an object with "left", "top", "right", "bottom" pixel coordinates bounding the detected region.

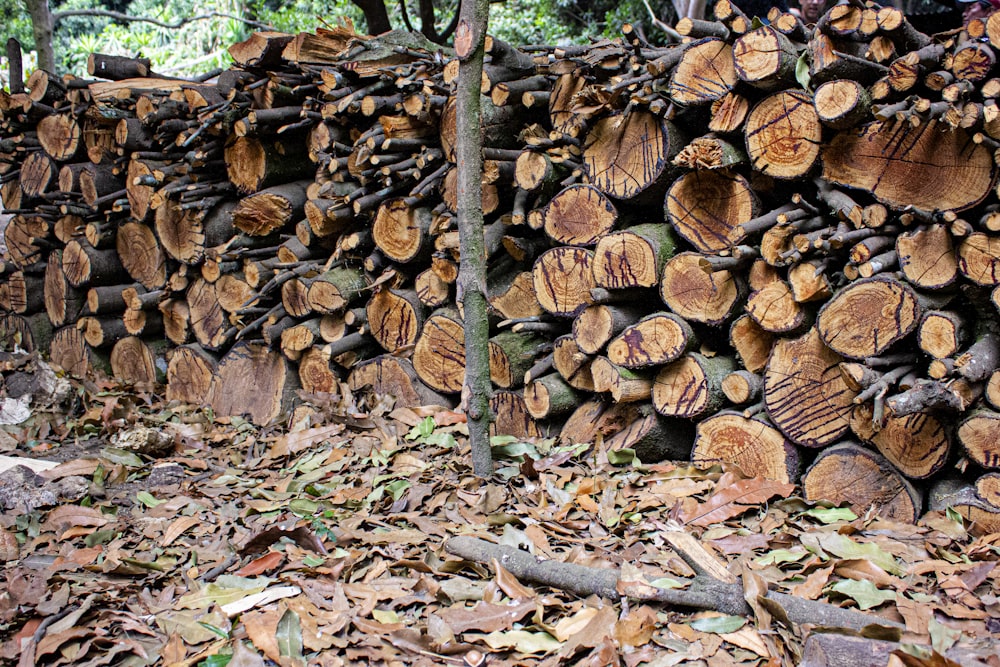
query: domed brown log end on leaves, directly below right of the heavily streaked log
[{"left": 802, "top": 443, "right": 921, "bottom": 523}]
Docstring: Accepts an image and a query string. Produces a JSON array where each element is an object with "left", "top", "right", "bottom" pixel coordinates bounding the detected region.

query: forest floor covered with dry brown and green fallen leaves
[{"left": 0, "top": 355, "right": 1000, "bottom": 667}]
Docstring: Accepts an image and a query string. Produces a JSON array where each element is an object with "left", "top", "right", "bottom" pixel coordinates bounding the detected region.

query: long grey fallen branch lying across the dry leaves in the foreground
[{"left": 444, "top": 537, "right": 902, "bottom": 631}]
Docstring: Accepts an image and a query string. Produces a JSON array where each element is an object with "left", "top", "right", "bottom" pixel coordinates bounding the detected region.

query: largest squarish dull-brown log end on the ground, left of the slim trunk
[{"left": 208, "top": 341, "right": 298, "bottom": 426}]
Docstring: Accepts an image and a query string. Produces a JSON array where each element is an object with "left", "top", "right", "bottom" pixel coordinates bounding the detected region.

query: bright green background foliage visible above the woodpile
[{"left": 0, "top": 0, "right": 673, "bottom": 86}]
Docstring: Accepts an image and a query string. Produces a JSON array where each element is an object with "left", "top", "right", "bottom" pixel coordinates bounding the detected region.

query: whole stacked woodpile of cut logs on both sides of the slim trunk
[{"left": 0, "top": 0, "right": 1000, "bottom": 528}]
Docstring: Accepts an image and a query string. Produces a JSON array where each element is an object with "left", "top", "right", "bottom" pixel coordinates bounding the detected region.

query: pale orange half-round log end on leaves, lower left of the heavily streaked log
[{"left": 691, "top": 411, "right": 799, "bottom": 484}]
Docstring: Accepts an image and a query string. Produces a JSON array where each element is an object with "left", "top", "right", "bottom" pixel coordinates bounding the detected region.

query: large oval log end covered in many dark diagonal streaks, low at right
[{"left": 764, "top": 327, "right": 855, "bottom": 447}]
